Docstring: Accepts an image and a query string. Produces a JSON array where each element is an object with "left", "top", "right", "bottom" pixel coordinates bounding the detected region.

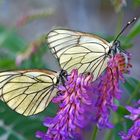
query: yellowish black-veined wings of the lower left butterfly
[{"left": 0, "top": 70, "right": 57, "bottom": 116}]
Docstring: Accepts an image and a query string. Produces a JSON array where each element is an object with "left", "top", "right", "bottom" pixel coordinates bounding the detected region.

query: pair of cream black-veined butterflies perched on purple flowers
[{"left": 0, "top": 19, "right": 134, "bottom": 116}]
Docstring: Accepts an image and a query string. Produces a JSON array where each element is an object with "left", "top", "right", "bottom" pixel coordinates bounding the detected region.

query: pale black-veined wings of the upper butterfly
[{"left": 47, "top": 29, "right": 109, "bottom": 80}]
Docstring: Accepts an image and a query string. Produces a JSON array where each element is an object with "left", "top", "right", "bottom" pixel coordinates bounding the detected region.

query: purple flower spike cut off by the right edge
[{"left": 120, "top": 100, "right": 140, "bottom": 140}]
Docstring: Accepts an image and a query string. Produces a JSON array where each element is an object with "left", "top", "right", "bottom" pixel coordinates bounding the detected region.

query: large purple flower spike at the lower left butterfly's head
[{"left": 36, "top": 70, "right": 93, "bottom": 140}]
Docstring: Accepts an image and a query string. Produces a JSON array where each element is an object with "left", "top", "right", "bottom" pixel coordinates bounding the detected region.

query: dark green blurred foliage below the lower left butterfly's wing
[{"left": 0, "top": 101, "right": 57, "bottom": 140}]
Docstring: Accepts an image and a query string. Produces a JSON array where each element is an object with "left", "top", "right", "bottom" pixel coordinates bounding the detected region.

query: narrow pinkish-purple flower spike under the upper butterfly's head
[{"left": 94, "top": 54, "right": 131, "bottom": 129}]
